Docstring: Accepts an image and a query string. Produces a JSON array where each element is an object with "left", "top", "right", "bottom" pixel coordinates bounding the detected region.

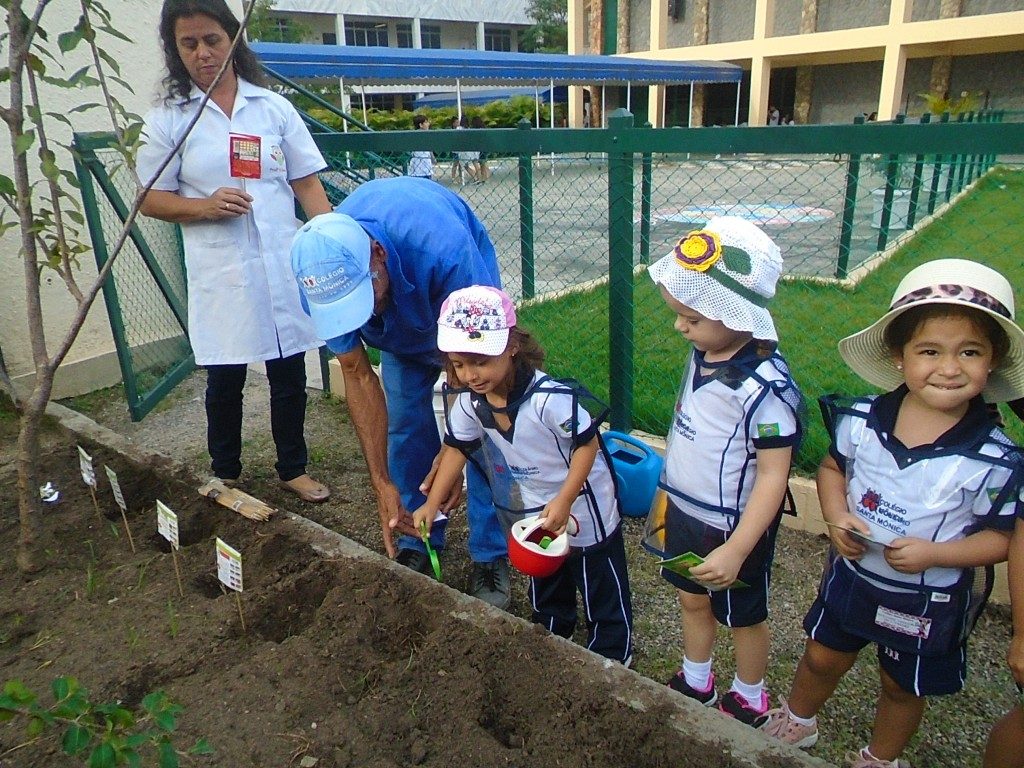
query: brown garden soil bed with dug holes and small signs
[{"left": 0, "top": 409, "right": 824, "bottom": 768}]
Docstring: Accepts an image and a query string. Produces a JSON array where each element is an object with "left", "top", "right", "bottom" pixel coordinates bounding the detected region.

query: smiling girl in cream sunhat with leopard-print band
[{"left": 761, "top": 259, "right": 1024, "bottom": 768}]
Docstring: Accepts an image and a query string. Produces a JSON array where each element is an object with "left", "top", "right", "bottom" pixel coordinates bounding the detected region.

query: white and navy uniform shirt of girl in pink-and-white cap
[{"left": 444, "top": 371, "right": 620, "bottom": 547}]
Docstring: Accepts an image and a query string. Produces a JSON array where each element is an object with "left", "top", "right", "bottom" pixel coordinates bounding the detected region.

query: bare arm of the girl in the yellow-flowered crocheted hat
[{"left": 690, "top": 446, "right": 793, "bottom": 587}]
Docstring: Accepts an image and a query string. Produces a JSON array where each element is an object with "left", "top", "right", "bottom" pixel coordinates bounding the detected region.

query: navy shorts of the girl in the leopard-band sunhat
[{"left": 804, "top": 593, "right": 967, "bottom": 696}]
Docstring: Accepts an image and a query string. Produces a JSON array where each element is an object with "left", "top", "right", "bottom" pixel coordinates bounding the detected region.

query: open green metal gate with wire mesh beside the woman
[{"left": 74, "top": 133, "right": 196, "bottom": 421}]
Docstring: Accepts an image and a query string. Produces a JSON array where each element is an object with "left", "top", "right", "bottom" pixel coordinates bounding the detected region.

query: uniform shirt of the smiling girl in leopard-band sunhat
[{"left": 822, "top": 385, "right": 1024, "bottom": 587}]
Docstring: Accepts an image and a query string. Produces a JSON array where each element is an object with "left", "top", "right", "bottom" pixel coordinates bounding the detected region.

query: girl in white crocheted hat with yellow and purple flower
[{"left": 644, "top": 216, "right": 802, "bottom": 725}]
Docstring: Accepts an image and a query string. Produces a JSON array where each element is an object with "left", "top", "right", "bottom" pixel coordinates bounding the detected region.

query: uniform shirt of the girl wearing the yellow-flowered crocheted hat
[{"left": 663, "top": 339, "right": 801, "bottom": 530}]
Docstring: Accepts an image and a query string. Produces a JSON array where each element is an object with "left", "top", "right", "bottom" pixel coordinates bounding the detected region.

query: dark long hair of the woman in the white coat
[{"left": 160, "top": 0, "right": 266, "bottom": 101}]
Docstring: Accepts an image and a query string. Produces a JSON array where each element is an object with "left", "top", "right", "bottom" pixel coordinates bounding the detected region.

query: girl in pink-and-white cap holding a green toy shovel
[{"left": 413, "top": 286, "right": 633, "bottom": 666}]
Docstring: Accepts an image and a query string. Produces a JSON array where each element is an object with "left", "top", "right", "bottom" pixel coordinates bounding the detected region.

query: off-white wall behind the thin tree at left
[{"left": 0, "top": 0, "right": 241, "bottom": 397}]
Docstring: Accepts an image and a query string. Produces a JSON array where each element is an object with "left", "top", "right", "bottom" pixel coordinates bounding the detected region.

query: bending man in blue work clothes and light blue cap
[{"left": 292, "top": 176, "right": 510, "bottom": 608}]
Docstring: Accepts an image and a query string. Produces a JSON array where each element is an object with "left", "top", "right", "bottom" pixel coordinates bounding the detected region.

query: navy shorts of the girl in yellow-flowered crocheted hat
[{"left": 662, "top": 497, "right": 779, "bottom": 627}]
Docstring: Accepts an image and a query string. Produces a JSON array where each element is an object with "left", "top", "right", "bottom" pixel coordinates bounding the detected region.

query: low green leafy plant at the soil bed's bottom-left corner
[{"left": 0, "top": 677, "right": 213, "bottom": 768}]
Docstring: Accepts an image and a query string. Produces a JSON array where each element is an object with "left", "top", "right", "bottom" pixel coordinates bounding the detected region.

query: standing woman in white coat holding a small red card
[{"left": 138, "top": 0, "right": 331, "bottom": 502}]
